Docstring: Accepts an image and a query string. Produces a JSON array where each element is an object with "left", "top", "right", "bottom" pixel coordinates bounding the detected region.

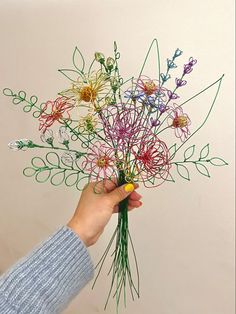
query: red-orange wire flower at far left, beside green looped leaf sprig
[{"left": 39, "top": 97, "right": 74, "bottom": 133}]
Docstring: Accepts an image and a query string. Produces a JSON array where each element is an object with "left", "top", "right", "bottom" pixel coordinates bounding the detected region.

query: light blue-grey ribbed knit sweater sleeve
[{"left": 0, "top": 226, "right": 94, "bottom": 314}]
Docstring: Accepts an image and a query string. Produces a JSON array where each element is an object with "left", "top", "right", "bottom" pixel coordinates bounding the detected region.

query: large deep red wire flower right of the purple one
[{"left": 132, "top": 132, "right": 171, "bottom": 187}]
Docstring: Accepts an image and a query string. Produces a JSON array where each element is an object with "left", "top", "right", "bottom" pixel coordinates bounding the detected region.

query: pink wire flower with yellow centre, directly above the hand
[{"left": 82, "top": 141, "right": 116, "bottom": 180}]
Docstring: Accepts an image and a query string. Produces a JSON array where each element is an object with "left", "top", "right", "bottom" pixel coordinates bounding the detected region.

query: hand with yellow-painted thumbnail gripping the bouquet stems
[{"left": 67, "top": 180, "right": 142, "bottom": 246}]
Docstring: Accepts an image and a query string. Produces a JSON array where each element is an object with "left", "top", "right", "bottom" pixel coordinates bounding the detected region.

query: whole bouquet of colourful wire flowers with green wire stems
[{"left": 3, "top": 39, "right": 227, "bottom": 308}]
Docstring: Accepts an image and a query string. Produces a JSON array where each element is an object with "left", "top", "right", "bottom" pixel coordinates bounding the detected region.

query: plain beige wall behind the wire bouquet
[{"left": 0, "top": 0, "right": 235, "bottom": 314}]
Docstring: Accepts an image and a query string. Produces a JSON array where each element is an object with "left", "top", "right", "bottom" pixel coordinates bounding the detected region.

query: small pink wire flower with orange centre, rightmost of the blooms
[{"left": 168, "top": 104, "right": 191, "bottom": 142}]
